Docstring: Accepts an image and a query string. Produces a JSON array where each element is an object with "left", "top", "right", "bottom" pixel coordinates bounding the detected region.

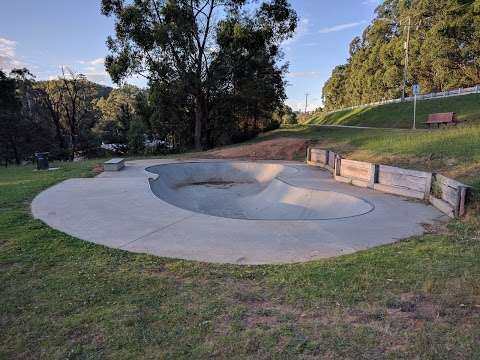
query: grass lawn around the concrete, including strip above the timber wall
[{"left": 0, "top": 134, "right": 480, "bottom": 359}]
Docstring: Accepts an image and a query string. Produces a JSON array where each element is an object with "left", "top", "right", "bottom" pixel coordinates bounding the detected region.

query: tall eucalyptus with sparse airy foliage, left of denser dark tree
[{"left": 102, "top": 0, "right": 297, "bottom": 149}]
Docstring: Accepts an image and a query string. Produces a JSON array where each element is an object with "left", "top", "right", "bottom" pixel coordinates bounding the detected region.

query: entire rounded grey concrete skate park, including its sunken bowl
[{"left": 32, "top": 160, "right": 443, "bottom": 264}]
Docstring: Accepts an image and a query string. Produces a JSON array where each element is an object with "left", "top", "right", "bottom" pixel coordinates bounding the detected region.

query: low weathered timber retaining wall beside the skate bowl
[{"left": 307, "top": 148, "right": 471, "bottom": 217}]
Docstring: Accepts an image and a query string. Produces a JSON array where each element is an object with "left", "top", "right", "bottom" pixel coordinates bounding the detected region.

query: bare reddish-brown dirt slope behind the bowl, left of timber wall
[{"left": 202, "top": 138, "right": 309, "bottom": 160}]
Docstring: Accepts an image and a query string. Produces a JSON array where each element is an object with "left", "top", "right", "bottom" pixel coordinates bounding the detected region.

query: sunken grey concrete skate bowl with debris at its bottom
[{"left": 147, "top": 161, "right": 374, "bottom": 221}]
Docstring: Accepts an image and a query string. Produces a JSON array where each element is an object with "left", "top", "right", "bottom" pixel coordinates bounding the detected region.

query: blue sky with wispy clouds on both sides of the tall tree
[{"left": 0, "top": 0, "right": 380, "bottom": 111}]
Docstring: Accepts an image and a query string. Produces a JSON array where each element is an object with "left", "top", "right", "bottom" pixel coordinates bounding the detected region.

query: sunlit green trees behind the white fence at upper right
[{"left": 323, "top": 0, "right": 480, "bottom": 110}]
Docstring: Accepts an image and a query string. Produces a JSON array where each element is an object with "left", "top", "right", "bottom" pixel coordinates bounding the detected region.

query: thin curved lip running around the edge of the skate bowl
[{"left": 145, "top": 159, "right": 375, "bottom": 222}]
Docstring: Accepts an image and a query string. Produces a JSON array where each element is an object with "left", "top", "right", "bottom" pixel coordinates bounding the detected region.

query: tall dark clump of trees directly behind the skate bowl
[{"left": 102, "top": 0, "right": 297, "bottom": 149}]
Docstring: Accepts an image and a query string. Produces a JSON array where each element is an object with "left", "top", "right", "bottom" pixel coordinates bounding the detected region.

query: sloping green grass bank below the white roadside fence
[{"left": 305, "top": 94, "right": 480, "bottom": 129}]
